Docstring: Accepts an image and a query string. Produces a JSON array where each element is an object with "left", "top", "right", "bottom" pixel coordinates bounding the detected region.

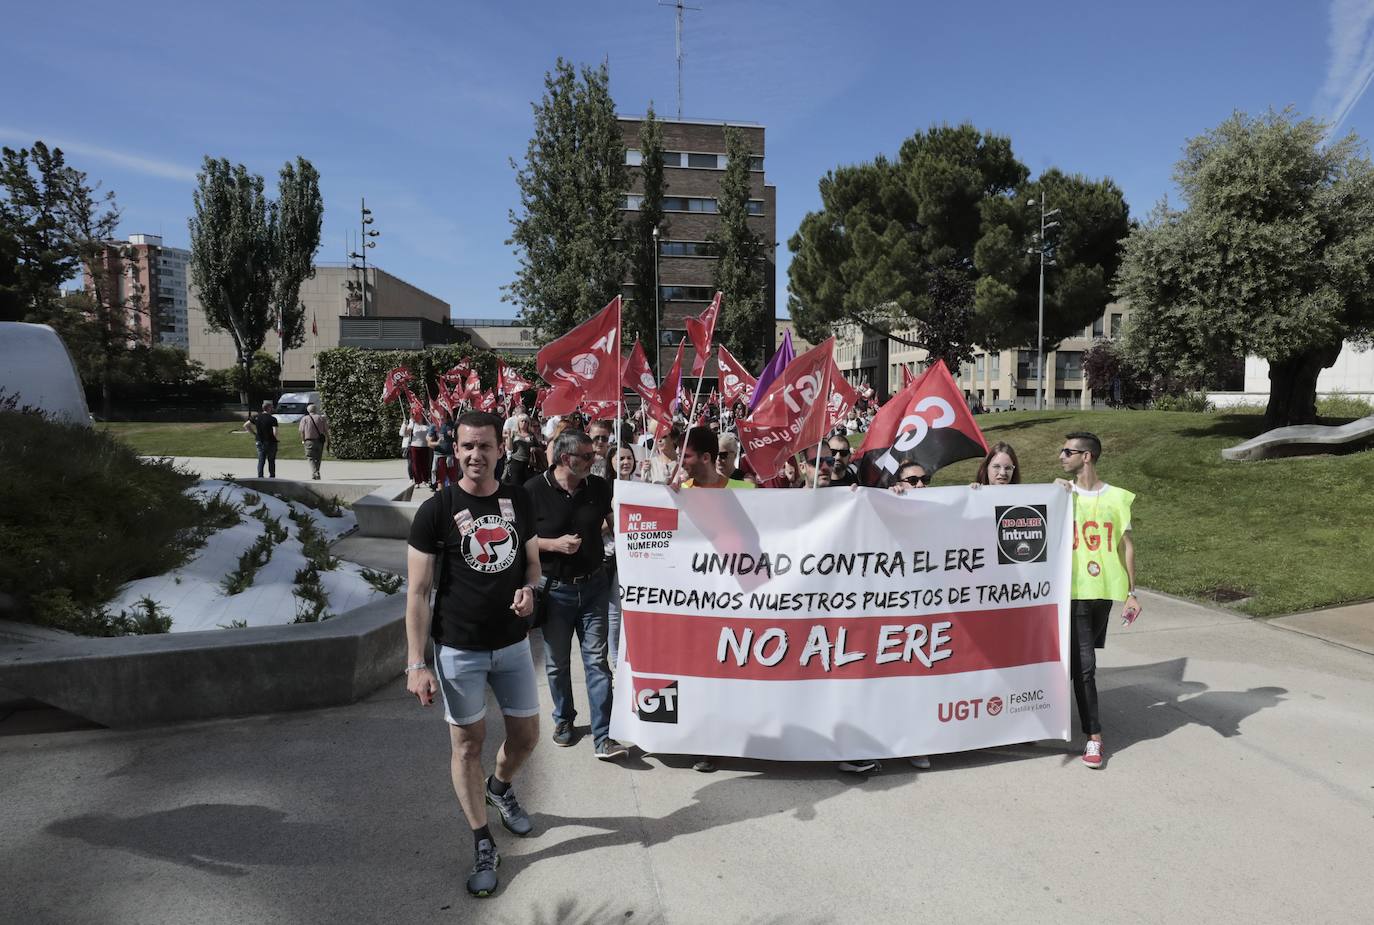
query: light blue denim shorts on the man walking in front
[{"left": 434, "top": 639, "right": 539, "bottom": 726}]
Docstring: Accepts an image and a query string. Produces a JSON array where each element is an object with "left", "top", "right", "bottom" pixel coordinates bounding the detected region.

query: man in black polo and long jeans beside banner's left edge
[{"left": 525, "top": 430, "right": 627, "bottom": 760}]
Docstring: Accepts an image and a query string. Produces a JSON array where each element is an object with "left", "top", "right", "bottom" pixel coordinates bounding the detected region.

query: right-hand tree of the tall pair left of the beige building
[{"left": 268, "top": 157, "right": 324, "bottom": 349}]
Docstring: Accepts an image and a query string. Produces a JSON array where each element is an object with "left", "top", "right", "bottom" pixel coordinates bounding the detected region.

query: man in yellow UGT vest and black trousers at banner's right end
[{"left": 1058, "top": 433, "right": 1140, "bottom": 768}]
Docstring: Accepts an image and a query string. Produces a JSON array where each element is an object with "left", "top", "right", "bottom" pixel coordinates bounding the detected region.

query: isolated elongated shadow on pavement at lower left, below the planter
[{"left": 47, "top": 803, "right": 353, "bottom": 877}]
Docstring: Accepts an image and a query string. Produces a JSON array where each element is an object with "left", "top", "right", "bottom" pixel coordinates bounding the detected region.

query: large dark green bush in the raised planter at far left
[{"left": 0, "top": 411, "right": 208, "bottom": 635}]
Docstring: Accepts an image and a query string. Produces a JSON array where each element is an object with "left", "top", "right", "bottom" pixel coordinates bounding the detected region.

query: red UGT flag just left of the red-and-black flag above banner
[{"left": 739, "top": 337, "right": 853, "bottom": 478}]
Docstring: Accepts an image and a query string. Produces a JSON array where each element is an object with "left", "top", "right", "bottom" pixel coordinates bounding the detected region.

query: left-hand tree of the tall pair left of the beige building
[{"left": 191, "top": 157, "right": 275, "bottom": 405}]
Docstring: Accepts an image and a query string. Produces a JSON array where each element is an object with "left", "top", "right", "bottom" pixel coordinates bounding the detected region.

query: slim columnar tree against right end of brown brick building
[{"left": 710, "top": 125, "right": 772, "bottom": 370}]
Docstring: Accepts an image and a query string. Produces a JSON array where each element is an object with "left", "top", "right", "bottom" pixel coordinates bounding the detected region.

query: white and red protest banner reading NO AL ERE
[{"left": 610, "top": 482, "right": 1073, "bottom": 761}]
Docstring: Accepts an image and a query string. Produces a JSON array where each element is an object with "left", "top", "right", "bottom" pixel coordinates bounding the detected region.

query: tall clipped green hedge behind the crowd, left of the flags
[{"left": 316, "top": 344, "right": 541, "bottom": 459}]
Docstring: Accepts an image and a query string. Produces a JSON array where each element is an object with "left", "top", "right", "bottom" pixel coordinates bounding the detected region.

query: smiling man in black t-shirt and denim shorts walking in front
[{"left": 405, "top": 411, "right": 540, "bottom": 896}]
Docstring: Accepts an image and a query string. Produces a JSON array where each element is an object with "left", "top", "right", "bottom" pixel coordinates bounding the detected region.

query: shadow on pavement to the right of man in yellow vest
[{"left": 1098, "top": 658, "right": 1287, "bottom": 753}]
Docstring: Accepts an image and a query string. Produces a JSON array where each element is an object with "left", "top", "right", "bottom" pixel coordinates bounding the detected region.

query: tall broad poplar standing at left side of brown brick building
[{"left": 503, "top": 58, "right": 629, "bottom": 344}]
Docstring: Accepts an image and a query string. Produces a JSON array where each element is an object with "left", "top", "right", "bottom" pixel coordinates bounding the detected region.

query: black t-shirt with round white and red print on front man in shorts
[{"left": 409, "top": 485, "right": 534, "bottom": 651}]
